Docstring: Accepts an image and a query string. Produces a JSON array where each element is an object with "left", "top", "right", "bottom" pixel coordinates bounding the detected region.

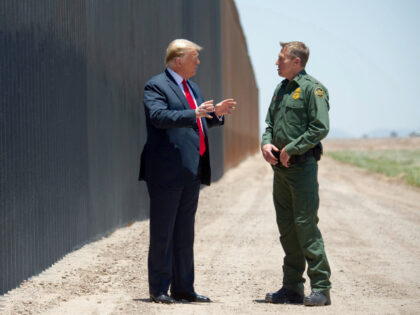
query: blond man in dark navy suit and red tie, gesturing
[{"left": 139, "top": 39, "right": 236, "bottom": 303}]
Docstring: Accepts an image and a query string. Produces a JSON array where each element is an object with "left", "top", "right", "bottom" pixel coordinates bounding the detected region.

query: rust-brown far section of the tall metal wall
[{"left": 221, "top": 0, "right": 259, "bottom": 170}]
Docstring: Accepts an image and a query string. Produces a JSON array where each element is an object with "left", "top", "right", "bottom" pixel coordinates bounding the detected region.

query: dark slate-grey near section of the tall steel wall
[{"left": 0, "top": 0, "right": 258, "bottom": 294}]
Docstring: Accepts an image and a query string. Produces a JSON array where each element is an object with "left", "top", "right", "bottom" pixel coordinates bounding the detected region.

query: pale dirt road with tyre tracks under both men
[{"left": 0, "top": 141, "right": 420, "bottom": 315}]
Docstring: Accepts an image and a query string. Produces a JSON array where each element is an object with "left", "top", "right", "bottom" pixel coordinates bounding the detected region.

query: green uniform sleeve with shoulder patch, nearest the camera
[{"left": 286, "top": 85, "right": 330, "bottom": 155}]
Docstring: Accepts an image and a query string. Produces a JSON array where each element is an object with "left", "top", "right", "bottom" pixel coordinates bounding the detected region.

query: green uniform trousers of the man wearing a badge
[{"left": 273, "top": 157, "right": 331, "bottom": 294}]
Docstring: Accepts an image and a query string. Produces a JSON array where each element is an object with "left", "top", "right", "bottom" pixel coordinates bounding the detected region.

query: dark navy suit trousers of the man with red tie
[{"left": 147, "top": 178, "right": 201, "bottom": 295}]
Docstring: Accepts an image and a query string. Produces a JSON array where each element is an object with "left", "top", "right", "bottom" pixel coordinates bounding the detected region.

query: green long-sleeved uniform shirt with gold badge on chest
[{"left": 261, "top": 70, "right": 330, "bottom": 156}]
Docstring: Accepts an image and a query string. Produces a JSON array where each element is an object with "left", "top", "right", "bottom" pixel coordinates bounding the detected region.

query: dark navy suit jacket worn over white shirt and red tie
[{"left": 139, "top": 70, "right": 224, "bottom": 186}]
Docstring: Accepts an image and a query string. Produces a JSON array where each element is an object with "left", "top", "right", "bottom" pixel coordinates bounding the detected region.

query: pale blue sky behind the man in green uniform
[{"left": 235, "top": 0, "right": 420, "bottom": 137}]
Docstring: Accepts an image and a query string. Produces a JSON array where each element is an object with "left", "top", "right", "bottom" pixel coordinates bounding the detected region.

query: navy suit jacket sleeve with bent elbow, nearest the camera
[{"left": 143, "top": 82, "right": 197, "bottom": 129}]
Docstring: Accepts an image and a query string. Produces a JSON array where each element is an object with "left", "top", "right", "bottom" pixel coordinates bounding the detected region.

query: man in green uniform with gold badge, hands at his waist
[{"left": 261, "top": 42, "right": 331, "bottom": 306}]
